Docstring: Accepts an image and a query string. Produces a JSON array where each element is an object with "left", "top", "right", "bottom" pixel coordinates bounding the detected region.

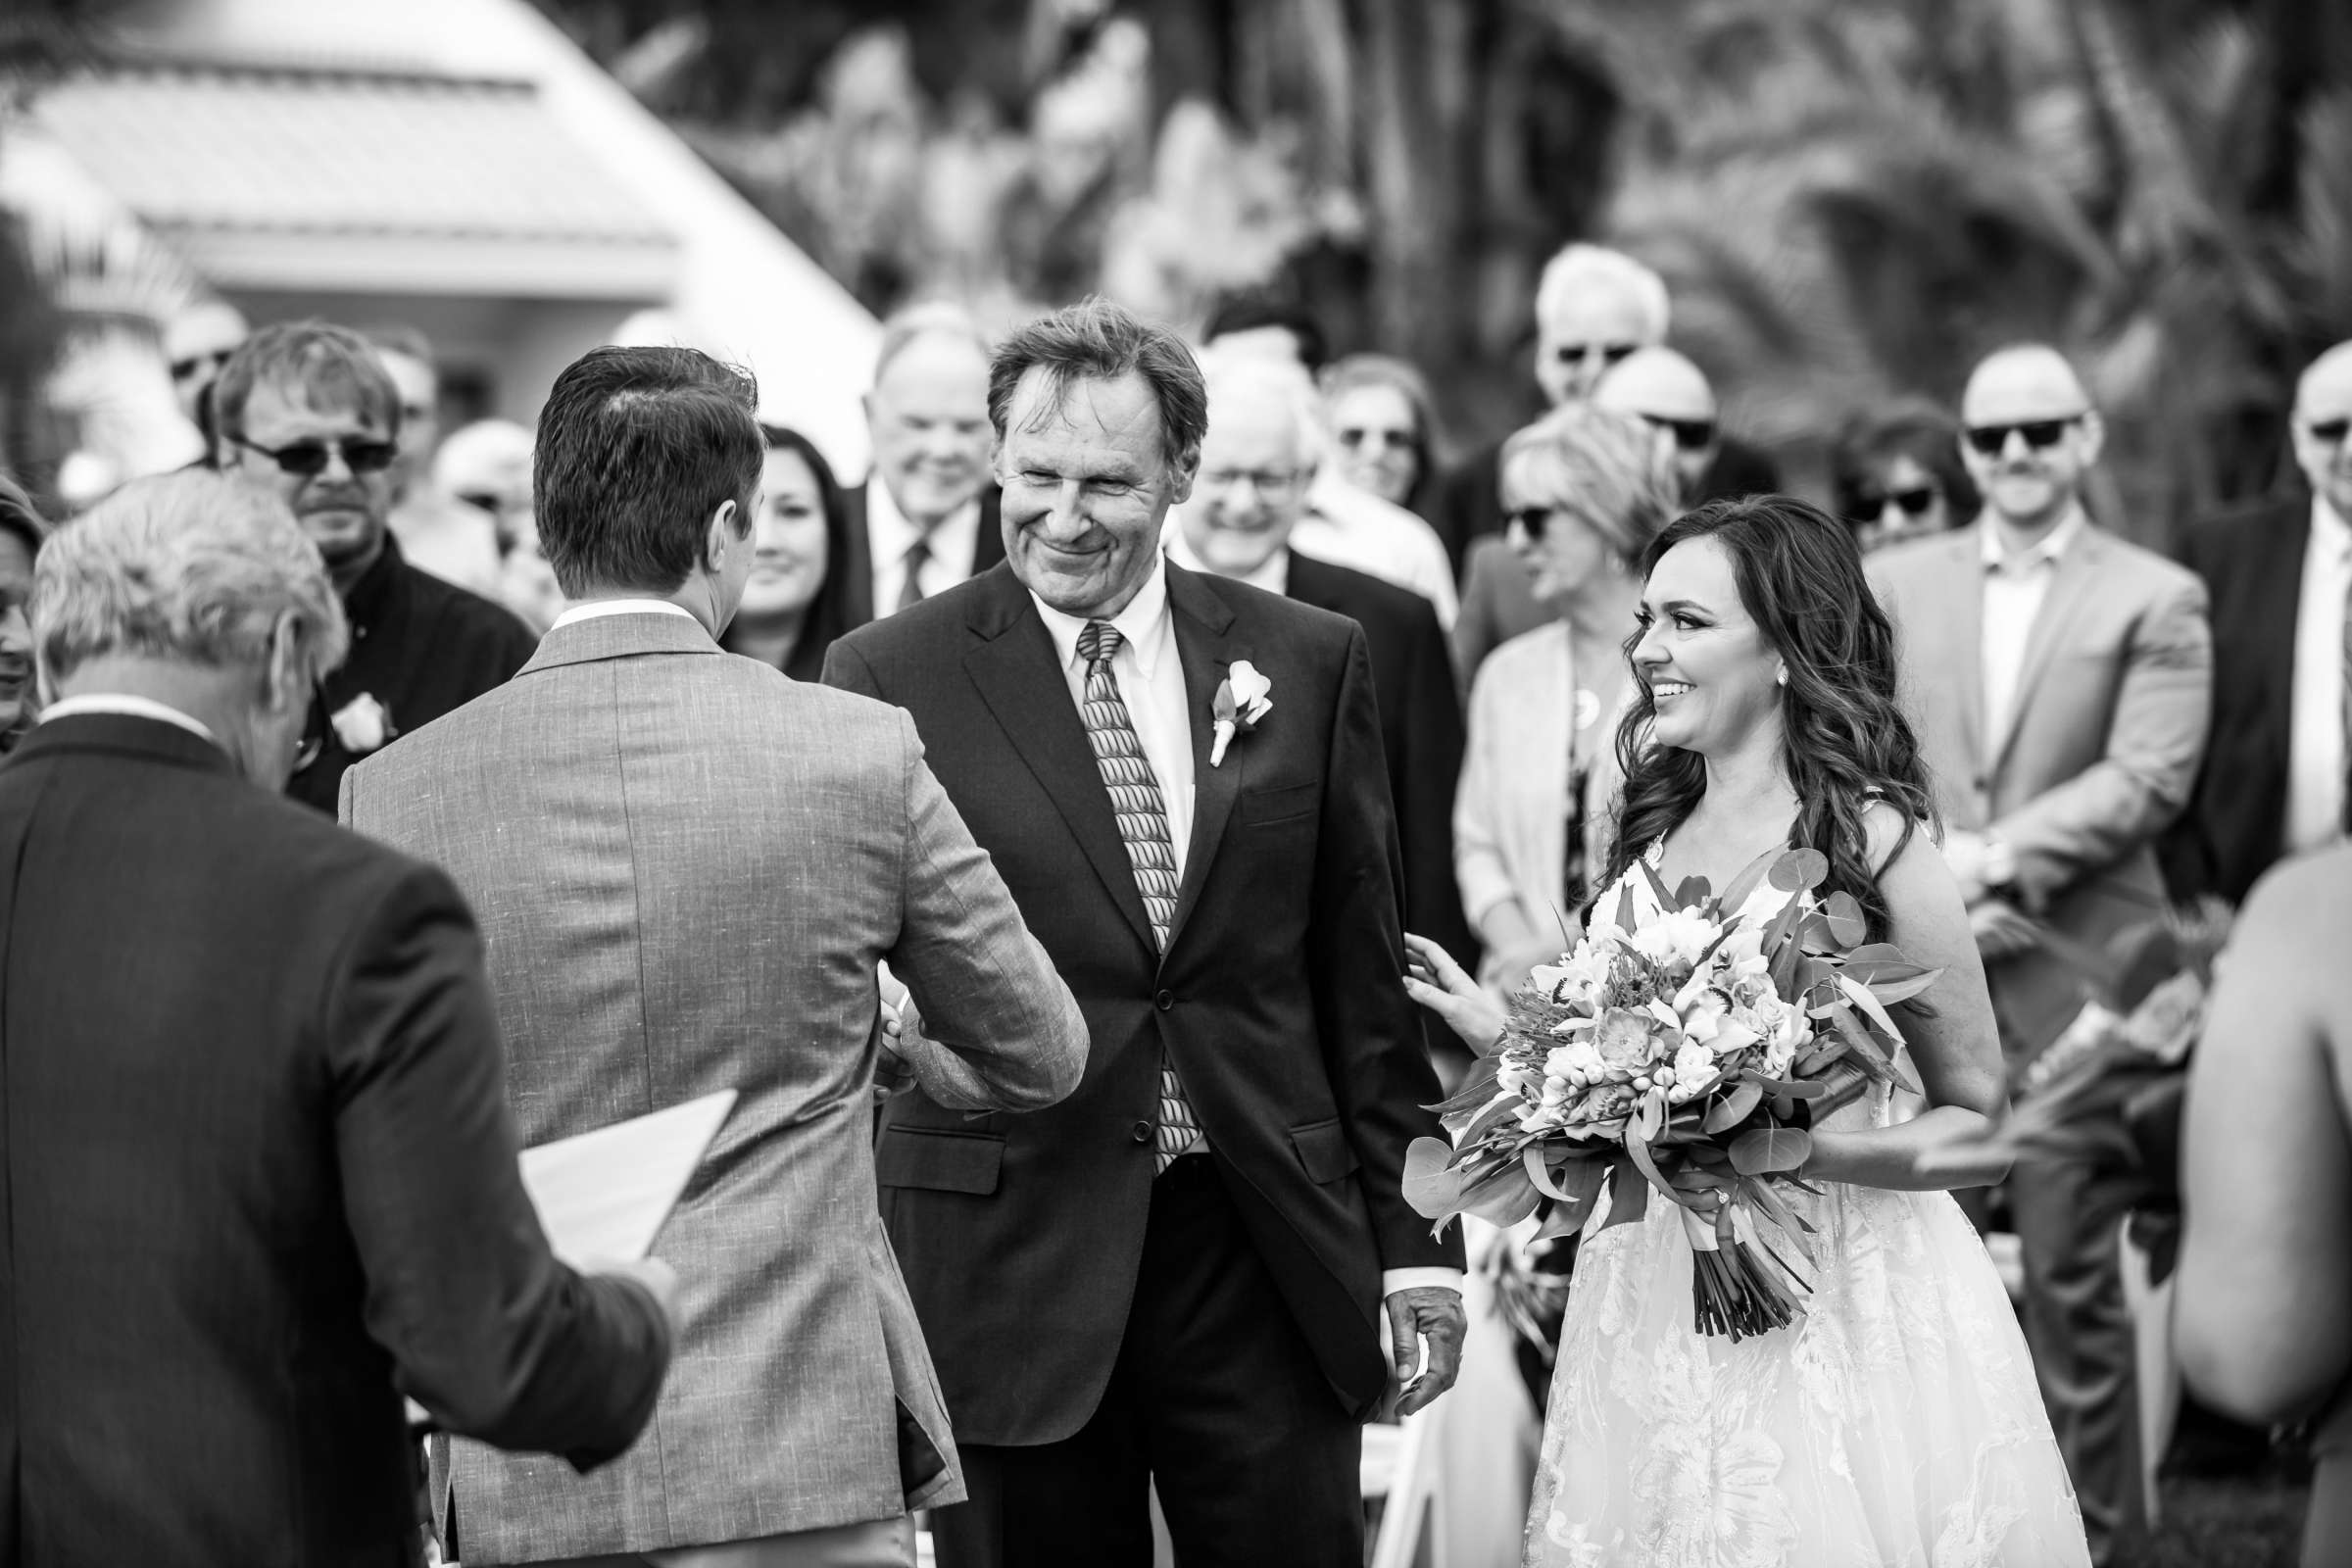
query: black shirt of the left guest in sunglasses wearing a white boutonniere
[{"left": 287, "top": 534, "right": 539, "bottom": 815}]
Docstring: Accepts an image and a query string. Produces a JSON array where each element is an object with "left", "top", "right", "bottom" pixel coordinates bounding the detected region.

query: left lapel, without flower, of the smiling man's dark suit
[{"left": 964, "top": 571, "right": 1174, "bottom": 948}]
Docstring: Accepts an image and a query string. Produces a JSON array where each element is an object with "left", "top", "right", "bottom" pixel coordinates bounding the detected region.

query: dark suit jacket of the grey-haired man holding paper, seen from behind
[{"left": 0, "top": 714, "right": 668, "bottom": 1566}]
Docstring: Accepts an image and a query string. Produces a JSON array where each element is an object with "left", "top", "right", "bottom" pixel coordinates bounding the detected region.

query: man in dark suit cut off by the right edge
[{"left": 2164, "top": 343, "right": 2352, "bottom": 903}]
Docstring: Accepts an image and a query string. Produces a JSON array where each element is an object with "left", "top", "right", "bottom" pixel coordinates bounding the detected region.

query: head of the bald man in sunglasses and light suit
[{"left": 1959, "top": 343, "right": 2103, "bottom": 536}]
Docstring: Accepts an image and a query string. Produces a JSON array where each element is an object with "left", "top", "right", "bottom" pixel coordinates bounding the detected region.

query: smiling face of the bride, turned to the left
[{"left": 1633, "top": 534, "right": 1783, "bottom": 757}]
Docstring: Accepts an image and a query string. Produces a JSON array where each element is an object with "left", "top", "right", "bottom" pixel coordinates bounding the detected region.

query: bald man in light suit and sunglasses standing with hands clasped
[{"left": 1870, "top": 343, "right": 2213, "bottom": 1563}]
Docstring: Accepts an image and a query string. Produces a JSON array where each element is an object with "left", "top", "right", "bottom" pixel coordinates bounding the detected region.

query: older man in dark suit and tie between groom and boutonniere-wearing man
[{"left": 833, "top": 303, "right": 1004, "bottom": 625}]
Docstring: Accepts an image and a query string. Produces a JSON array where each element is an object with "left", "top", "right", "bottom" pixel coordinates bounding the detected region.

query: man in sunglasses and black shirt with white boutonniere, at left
[{"left": 214, "top": 322, "right": 536, "bottom": 811}]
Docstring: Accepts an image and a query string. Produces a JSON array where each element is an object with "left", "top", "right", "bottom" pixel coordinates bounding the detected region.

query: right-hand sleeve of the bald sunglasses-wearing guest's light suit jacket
[{"left": 1989, "top": 578, "right": 2213, "bottom": 906}]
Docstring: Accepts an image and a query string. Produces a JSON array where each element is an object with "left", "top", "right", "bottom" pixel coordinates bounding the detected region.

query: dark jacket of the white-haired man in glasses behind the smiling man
[{"left": 1289, "top": 550, "right": 1477, "bottom": 968}]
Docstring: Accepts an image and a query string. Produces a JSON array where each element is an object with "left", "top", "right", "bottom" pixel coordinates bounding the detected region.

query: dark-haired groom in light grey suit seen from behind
[{"left": 341, "top": 348, "right": 1087, "bottom": 1568}]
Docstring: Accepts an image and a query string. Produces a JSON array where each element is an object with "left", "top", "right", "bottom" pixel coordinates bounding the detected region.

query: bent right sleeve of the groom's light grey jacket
[{"left": 884, "top": 705, "right": 1087, "bottom": 1109}]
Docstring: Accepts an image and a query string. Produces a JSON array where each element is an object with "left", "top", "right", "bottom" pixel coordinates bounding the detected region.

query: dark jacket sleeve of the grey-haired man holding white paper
[{"left": 319, "top": 864, "right": 670, "bottom": 1469}]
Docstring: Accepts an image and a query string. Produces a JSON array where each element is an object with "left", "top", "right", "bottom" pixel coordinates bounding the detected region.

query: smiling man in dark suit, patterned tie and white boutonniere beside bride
[{"left": 825, "top": 301, "right": 1463, "bottom": 1568}]
